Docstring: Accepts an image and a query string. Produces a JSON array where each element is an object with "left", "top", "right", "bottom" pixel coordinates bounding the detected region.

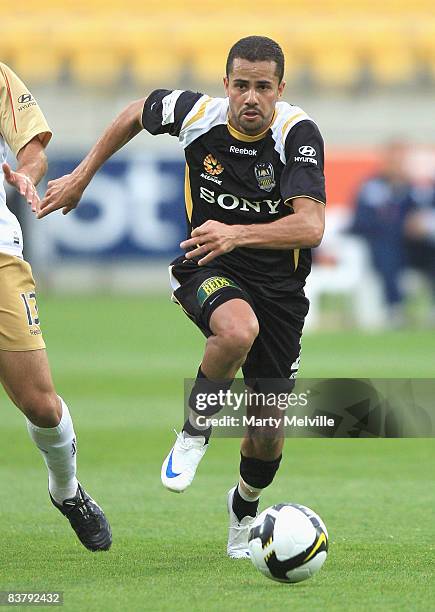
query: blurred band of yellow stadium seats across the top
[{"left": 0, "top": 0, "right": 435, "bottom": 90}]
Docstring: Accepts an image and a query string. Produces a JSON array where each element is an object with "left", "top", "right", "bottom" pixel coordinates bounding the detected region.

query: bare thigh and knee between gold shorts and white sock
[{"left": 0, "top": 349, "right": 56, "bottom": 411}]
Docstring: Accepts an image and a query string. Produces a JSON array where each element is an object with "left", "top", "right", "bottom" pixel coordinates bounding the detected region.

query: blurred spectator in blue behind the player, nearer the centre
[{"left": 351, "top": 141, "right": 413, "bottom": 327}]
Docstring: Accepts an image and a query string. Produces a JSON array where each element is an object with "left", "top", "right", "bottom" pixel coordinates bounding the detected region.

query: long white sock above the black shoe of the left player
[{"left": 26, "top": 398, "right": 77, "bottom": 504}]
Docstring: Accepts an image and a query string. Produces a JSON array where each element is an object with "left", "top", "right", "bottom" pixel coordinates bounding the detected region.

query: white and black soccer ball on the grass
[{"left": 248, "top": 503, "right": 328, "bottom": 582}]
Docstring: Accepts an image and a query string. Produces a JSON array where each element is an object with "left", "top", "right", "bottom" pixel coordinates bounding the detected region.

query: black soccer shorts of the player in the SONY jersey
[{"left": 169, "top": 256, "right": 309, "bottom": 391}]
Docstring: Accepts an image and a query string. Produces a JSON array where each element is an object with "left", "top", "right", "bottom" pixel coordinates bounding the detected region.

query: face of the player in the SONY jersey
[{"left": 224, "top": 58, "right": 285, "bottom": 136}]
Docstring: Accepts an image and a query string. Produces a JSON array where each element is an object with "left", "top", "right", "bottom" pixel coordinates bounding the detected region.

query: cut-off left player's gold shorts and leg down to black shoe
[{"left": 0, "top": 255, "right": 111, "bottom": 550}]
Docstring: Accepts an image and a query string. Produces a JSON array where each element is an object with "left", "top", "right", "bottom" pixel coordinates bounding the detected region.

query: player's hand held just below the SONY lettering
[{"left": 180, "top": 221, "right": 242, "bottom": 266}]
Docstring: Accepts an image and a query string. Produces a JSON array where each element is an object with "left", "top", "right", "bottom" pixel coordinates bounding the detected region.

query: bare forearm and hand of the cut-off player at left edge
[{"left": 2, "top": 136, "right": 47, "bottom": 212}]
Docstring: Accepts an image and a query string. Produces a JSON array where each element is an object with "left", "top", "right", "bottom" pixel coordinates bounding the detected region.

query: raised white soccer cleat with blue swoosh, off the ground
[{"left": 161, "top": 431, "right": 208, "bottom": 493}]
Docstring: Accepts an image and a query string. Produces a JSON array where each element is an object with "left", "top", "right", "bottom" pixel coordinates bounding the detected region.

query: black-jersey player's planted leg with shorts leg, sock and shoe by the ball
[{"left": 227, "top": 295, "right": 308, "bottom": 558}]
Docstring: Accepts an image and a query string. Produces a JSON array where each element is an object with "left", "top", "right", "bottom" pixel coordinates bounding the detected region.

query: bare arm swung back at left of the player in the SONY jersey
[{"left": 38, "top": 98, "right": 145, "bottom": 219}]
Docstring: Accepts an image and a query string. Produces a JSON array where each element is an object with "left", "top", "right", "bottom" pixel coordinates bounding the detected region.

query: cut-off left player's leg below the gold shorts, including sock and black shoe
[{"left": 0, "top": 349, "right": 112, "bottom": 551}]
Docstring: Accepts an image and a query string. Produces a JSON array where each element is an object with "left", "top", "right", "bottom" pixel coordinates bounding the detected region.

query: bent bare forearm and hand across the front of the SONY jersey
[{"left": 180, "top": 198, "right": 325, "bottom": 265}]
